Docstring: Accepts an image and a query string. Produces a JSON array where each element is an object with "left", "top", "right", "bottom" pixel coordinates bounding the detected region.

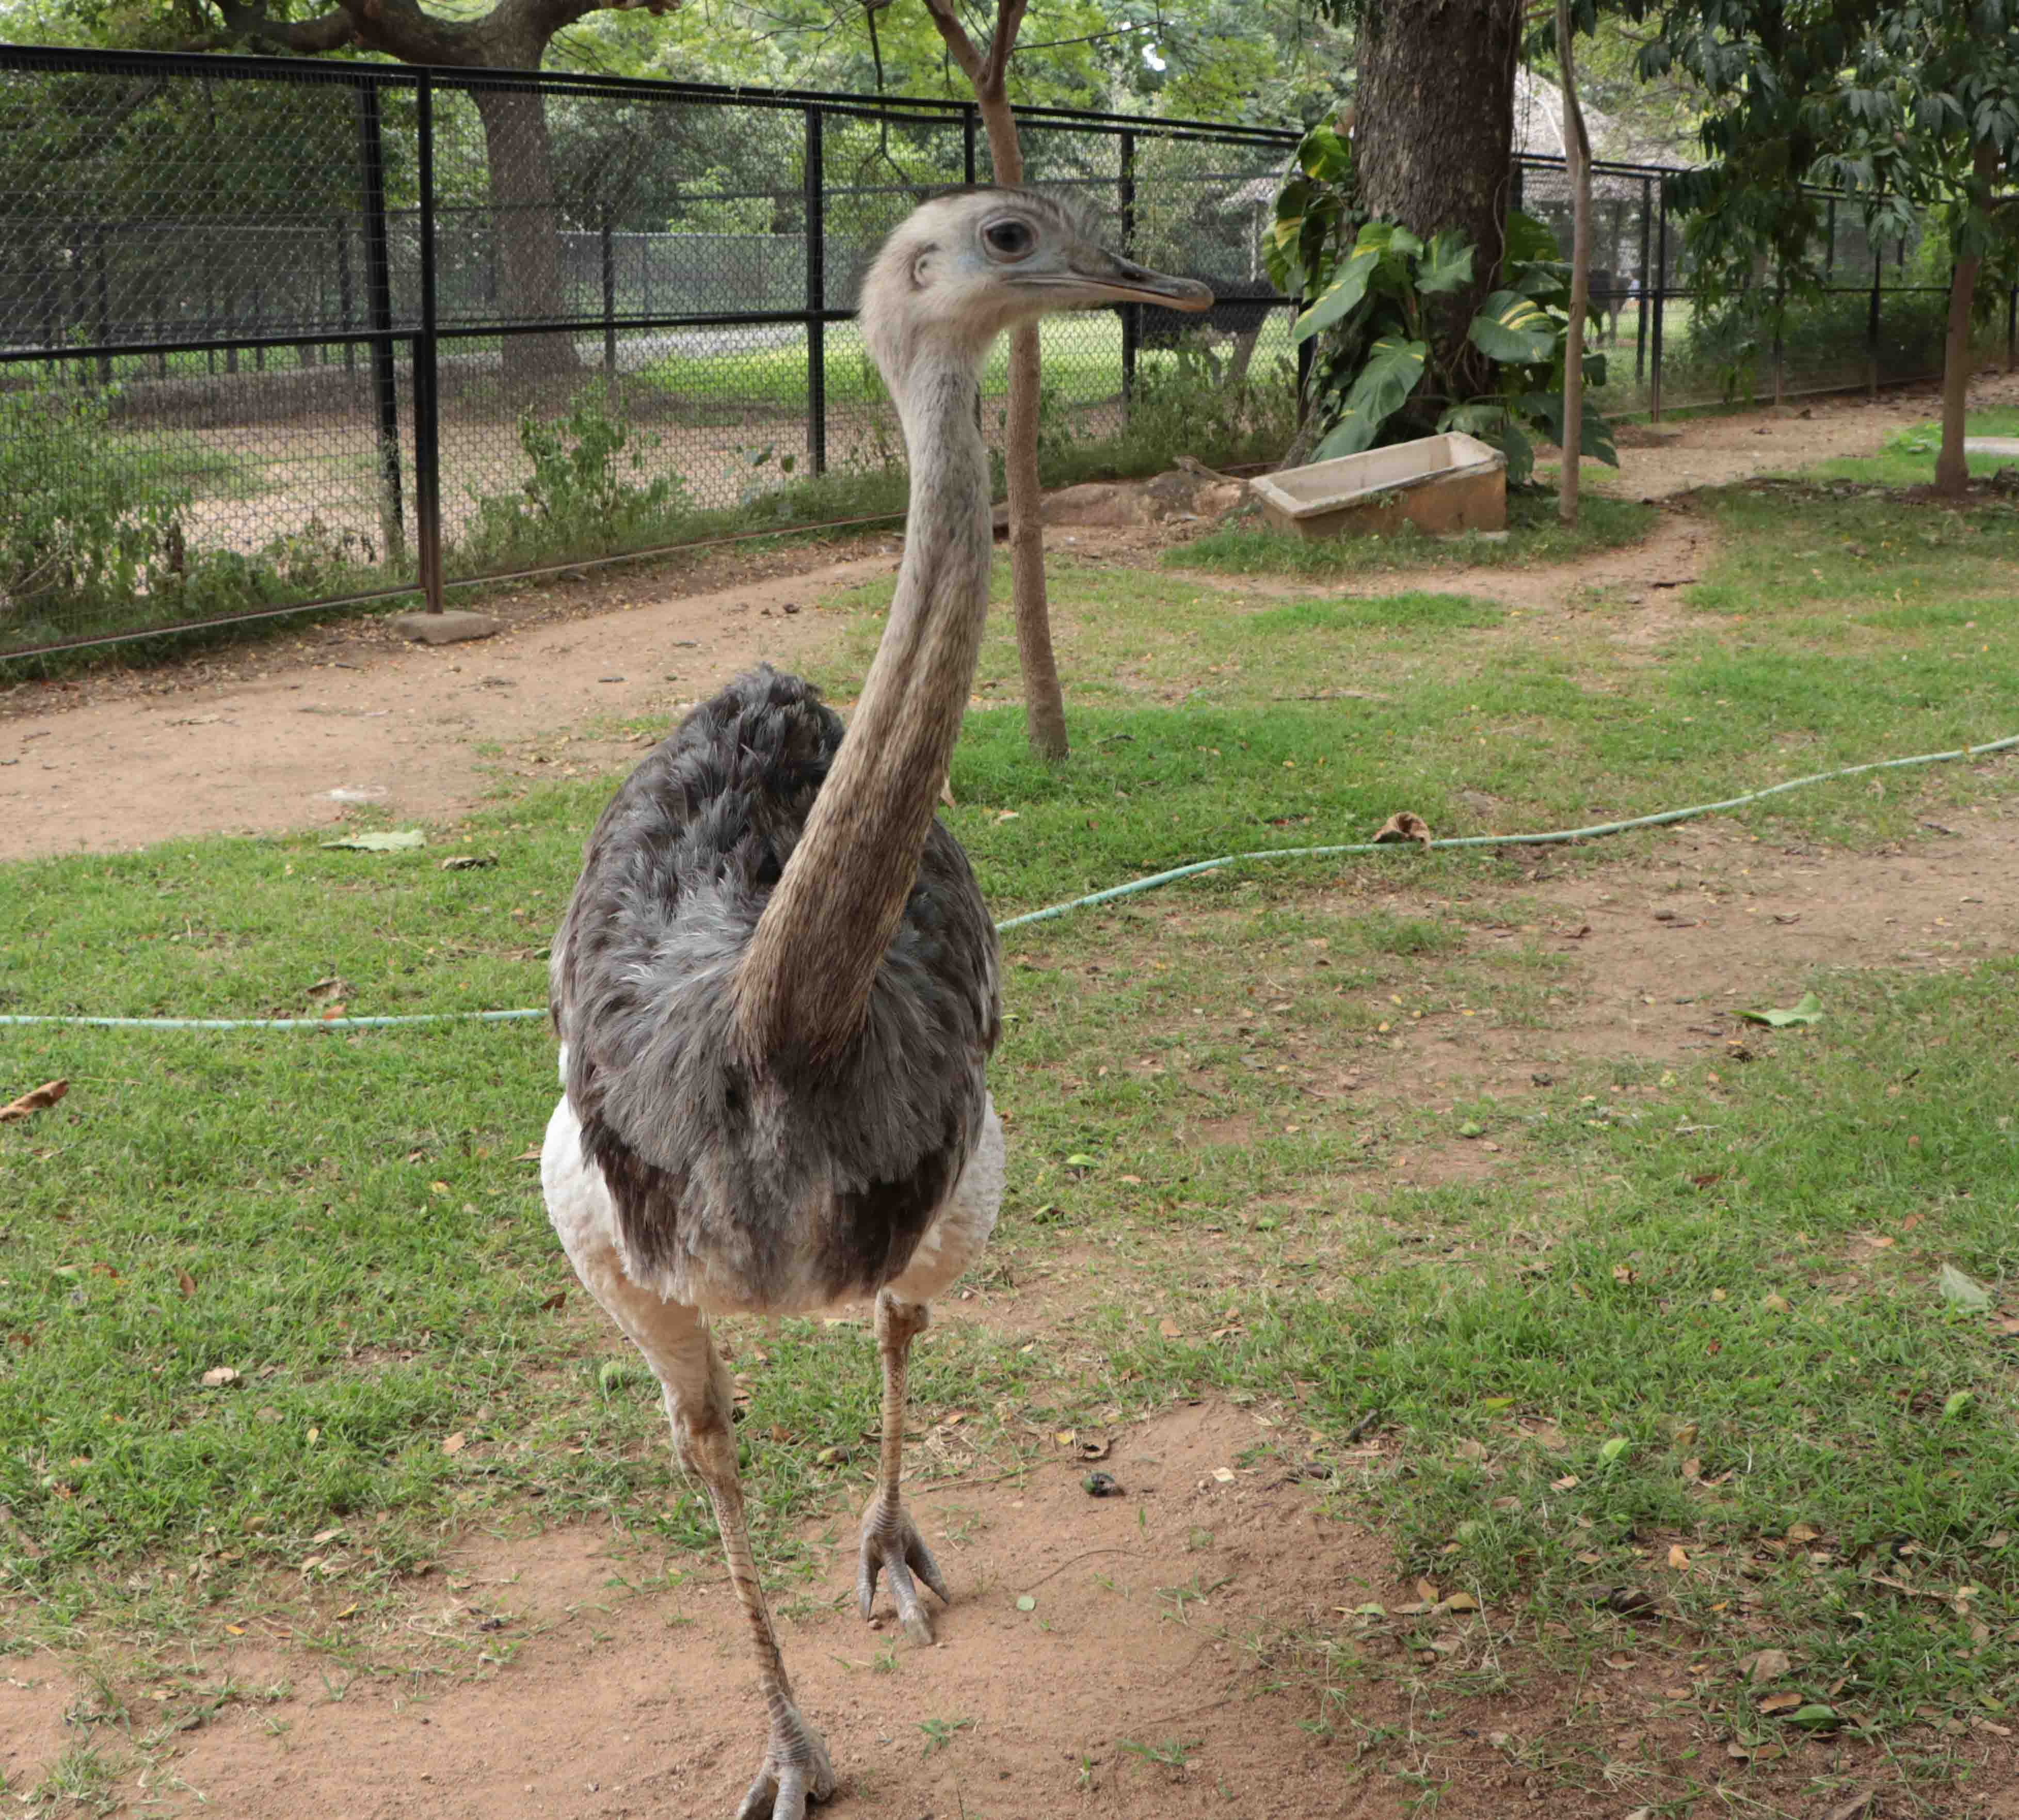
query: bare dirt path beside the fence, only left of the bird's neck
[{"left": 0, "top": 553, "right": 894, "bottom": 860}]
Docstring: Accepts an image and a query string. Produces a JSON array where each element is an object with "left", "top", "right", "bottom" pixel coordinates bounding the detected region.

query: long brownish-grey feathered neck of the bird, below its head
[{"left": 735, "top": 341, "right": 994, "bottom": 1064}]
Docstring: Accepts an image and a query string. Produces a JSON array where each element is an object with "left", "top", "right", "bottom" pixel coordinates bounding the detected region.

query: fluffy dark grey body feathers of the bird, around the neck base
[{"left": 551, "top": 668, "right": 999, "bottom": 1309}]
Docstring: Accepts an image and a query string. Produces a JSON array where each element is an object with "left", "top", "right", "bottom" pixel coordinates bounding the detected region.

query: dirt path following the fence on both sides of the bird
[{"left": 0, "top": 376, "right": 1970, "bottom": 860}]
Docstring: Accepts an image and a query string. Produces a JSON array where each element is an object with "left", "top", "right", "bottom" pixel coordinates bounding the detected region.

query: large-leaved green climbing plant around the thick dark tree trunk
[{"left": 1264, "top": 127, "right": 1617, "bottom": 485}]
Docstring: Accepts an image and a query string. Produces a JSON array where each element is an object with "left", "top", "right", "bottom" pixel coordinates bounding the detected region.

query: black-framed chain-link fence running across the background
[{"left": 0, "top": 46, "right": 2002, "bottom": 657}]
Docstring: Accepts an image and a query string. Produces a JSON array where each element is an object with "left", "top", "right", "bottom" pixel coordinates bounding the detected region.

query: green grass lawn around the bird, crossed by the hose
[{"left": 0, "top": 472, "right": 2019, "bottom": 1785}]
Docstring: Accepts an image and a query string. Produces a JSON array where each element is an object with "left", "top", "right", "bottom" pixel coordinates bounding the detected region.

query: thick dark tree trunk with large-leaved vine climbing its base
[{"left": 1353, "top": 0, "right": 1523, "bottom": 392}]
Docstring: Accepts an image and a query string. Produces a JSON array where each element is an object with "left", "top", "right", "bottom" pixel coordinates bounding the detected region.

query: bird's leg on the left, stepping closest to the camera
[{"left": 555, "top": 1220, "right": 834, "bottom": 1820}]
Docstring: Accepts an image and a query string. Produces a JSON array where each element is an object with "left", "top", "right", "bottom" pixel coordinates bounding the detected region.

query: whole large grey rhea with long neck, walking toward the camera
[{"left": 541, "top": 190, "right": 1211, "bottom": 1820}]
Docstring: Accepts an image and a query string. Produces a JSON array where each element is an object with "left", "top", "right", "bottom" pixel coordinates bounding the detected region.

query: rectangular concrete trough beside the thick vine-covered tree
[{"left": 1250, "top": 430, "right": 1508, "bottom": 537}]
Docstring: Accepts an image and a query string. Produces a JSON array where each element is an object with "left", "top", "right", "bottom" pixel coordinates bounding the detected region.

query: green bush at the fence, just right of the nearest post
[{"left": 458, "top": 380, "right": 688, "bottom": 568}]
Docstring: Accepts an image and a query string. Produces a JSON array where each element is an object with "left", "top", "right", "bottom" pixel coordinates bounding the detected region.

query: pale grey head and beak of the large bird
[{"left": 860, "top": 190, "right": 1213, "bottom": 378}]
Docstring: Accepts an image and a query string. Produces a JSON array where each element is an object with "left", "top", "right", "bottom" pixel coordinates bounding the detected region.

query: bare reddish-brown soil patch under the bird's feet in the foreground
[{"left": 0, "top": 1404, "right": 2015, "bottom": 1820}]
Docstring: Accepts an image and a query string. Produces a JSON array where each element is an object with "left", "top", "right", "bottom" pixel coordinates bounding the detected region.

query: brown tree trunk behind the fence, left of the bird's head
[{"left": 470, "top": 85, "right": 582, "bottom": 380}]
